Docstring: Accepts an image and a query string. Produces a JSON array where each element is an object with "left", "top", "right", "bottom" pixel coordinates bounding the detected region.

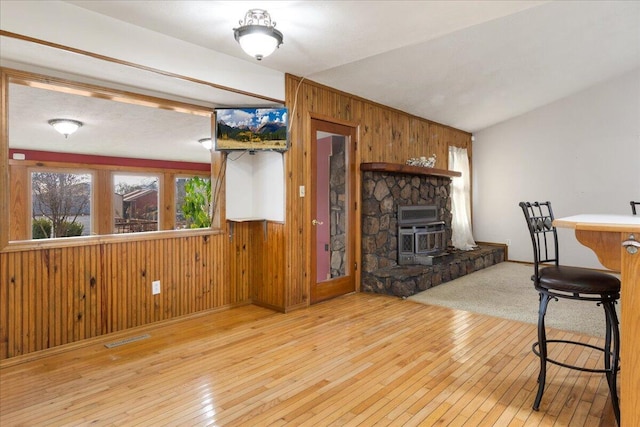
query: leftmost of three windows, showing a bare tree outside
[{"left": 31, "top": 171, "right": 92, "bottom": 239}]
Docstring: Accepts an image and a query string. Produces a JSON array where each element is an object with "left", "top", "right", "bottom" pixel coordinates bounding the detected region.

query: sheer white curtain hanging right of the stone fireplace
[{"left": 449, "top": 147, "right": 476, "bottom": 251}]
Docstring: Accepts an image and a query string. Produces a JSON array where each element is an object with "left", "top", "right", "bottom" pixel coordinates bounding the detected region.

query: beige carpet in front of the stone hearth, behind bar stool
[{"left": 408, "top": 262, "right": 620, "bottom": 337}]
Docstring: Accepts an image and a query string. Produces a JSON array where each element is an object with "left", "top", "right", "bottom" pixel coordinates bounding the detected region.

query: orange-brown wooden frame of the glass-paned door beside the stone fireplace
[{"left": 305, "top": 114, "right": 361, "bottom": 304}]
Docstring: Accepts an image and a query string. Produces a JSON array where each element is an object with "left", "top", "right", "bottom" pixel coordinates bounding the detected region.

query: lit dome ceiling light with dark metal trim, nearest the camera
[{"left": 233, "top": 9, "right": 283, "bottom": 61}]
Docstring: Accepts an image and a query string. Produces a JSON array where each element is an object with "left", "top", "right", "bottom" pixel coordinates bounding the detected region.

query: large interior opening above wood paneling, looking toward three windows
[{"left": 0, "top": 68, "right": 213, "bottom": 244}]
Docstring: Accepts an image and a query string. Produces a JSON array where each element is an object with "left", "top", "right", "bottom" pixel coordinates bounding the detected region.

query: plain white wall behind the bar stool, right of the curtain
[{"left": 473, "top": 69, "right": 640, "bottom": 268}]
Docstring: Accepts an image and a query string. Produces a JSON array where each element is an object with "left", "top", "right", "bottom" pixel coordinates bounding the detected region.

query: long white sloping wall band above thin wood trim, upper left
[{"left": 0, "top": 0, "right": 284, "bottom": 104}]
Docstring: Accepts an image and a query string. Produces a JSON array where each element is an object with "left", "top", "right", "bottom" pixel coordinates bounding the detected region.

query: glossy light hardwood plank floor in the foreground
[{"left": 0, "top": 294, "right": 613, "bottom": 427}]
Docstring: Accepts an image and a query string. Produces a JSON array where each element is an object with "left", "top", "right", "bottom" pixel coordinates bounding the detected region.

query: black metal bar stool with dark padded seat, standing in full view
[{"left": 520, "top": 202, "right": 620, "bottom": 424}]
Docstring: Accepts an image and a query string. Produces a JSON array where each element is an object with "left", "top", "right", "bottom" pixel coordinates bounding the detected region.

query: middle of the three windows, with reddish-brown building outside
[{"left": 113, "top": 174, "right": 159, "bottom": 233}]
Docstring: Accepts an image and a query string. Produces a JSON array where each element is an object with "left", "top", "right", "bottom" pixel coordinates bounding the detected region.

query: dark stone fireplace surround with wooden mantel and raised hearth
[{"left": 360, "top": 163, "right": 505, "bottom": 297}]
